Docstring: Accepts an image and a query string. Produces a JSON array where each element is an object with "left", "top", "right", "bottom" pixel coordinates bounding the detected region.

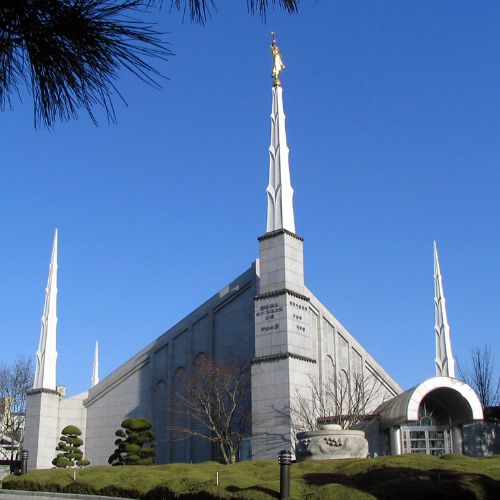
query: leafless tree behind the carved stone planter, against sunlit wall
[{"left": 290, "top": 371, "right": 390, "bottom": 435}]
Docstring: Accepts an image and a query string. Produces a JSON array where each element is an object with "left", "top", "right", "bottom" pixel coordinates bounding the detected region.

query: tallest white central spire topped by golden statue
[{"left": 266, "top": 33, "right": 295, "bottom": 233}]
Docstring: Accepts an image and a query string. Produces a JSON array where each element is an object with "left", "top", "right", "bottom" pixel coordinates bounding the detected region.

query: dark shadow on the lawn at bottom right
[{"left": 303, "top": 467, "right": 500, "bottom": 500}]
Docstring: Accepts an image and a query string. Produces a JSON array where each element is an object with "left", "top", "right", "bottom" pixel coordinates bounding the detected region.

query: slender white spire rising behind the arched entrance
[{"left": 434, "top": 242, "right": 455, "bottom": 378}]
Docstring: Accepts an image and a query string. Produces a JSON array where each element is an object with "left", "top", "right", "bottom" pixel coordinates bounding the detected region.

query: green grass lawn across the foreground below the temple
[{"left": 2, "top": 454, "right": 500, "bottom": 500}]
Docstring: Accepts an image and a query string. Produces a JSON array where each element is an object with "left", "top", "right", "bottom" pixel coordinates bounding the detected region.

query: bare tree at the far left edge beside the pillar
[{"left": 0, "top": 357, "right": 33, "bottom": 460}]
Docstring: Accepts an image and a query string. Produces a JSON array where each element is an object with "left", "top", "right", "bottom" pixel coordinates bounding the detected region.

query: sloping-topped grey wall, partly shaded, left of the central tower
[{"left": 84, "top": 266, "right": 256, "bottom": 465}]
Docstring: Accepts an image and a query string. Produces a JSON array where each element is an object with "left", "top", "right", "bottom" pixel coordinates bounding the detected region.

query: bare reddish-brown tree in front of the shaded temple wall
[{"left": 172, "top": 356, "right": 250, "bottom": 464}]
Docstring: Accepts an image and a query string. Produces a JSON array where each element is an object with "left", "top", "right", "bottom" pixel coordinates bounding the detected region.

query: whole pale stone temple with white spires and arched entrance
[{"left": 24, "top": 38, "right": 483, "bottom": 469}]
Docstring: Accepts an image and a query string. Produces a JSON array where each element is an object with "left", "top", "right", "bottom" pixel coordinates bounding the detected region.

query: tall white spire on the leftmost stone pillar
[{"left": 33, "top": 229, "right": 57, "bottom": 391}]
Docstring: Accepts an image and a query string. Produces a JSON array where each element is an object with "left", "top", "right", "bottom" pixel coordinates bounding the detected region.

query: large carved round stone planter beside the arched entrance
[{"left": 295, "top": 424, "right": 368, "bottom": 461}]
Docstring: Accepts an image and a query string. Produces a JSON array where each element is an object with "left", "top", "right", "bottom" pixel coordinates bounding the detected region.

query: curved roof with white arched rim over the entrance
[{"left": 375, "top": 377, "right": 483, "bottom": 423}]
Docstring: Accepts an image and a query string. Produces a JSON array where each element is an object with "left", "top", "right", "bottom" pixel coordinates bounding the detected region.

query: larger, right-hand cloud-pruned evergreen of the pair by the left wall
[{"left": 108, "top": 418, "right": 156, "bottom": 465}]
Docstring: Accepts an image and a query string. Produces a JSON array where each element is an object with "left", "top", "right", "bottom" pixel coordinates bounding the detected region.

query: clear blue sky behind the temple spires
[{"left": 0, "top": 0, "right": 500, "bottom": 393}]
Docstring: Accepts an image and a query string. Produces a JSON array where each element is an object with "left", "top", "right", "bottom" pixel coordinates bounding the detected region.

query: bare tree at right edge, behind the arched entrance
[{"left": 458, "top": 345, "right": 500, "bottom": 408}]
